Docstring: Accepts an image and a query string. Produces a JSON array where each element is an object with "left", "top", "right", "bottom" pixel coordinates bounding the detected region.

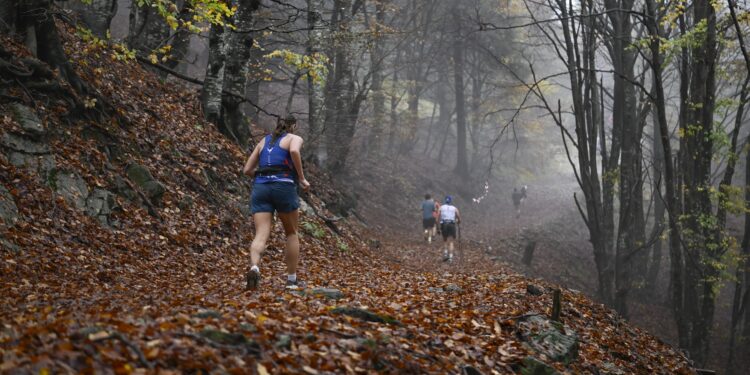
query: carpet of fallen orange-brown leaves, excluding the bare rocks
[{"left": 0, "top": 25, "right": 686, "bottom": 375}]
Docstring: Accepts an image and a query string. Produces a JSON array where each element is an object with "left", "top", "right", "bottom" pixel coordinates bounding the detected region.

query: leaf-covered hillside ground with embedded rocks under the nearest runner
[{"left": 0, "top": 25, "right": 692, "bottom": 374}]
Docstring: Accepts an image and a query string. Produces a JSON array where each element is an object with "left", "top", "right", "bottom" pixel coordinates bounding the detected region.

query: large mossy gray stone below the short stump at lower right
[{"left": 518, "top": 315, "right": 578, "bottom": 364}]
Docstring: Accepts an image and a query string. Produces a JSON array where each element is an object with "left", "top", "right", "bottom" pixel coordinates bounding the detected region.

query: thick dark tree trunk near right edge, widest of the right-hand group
[{"left": 683, "top": 0, "right": 721, "bottom": 366}]
